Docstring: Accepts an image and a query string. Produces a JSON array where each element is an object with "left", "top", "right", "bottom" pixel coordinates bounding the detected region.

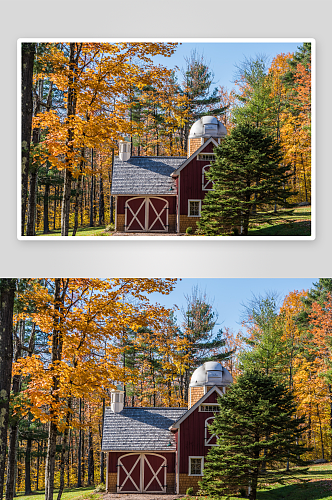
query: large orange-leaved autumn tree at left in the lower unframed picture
[{"left": 15, "top": 278, "right": 174, "bottom": 499}]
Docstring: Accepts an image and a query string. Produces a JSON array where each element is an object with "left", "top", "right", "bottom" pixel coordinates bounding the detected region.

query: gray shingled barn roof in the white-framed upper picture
[{"left": 112, "top": 156, "right": 186, "bottom": 195}]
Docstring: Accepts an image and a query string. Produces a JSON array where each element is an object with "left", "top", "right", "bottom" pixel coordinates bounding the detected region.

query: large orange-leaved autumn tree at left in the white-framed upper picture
[{"left": 29, "top": 42, "right": 176, "bottom": 236}]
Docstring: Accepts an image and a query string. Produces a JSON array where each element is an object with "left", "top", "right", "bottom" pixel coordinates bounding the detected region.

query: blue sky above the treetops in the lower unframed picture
[{"left": 149, "top": 278, "right": 319, "bottom": 333}]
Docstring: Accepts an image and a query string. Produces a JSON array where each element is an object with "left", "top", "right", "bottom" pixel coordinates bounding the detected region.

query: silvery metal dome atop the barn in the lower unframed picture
[{"left": 190, "top": 361, "right": 233, "bottom": 387}]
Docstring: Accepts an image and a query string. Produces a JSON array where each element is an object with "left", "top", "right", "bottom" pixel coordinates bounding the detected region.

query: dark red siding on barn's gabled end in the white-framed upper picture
[{"left": 180, "top": 142, "right": 215, "bottom": 215}]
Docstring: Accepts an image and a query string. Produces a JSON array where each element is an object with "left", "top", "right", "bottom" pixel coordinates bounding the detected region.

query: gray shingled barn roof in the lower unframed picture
[{"left": 102, "top": 407, "right": 188, "bottom": 451}]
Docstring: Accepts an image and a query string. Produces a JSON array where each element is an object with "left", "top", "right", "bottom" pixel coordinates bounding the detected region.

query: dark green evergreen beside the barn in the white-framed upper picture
[{"left": 198, "top": 124, "right": 295, "bottom": 236}]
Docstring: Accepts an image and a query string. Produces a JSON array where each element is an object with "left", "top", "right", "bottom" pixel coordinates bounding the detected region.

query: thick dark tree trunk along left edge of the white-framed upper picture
[{"left": 21, "top": 43, "right": 36, "bottom": 236}]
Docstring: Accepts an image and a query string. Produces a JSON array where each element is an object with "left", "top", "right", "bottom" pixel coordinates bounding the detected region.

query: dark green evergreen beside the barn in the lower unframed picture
[{"left": 200, "top": 371, "right": 307, "bottom": 500}]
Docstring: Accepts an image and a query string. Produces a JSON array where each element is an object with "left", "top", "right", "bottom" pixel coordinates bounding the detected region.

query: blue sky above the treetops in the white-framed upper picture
[{"left": 154, "top": 42, "right": 301, "bottom": 90}]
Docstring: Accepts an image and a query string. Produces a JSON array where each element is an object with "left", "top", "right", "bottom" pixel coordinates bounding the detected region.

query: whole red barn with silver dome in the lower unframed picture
[{"left": 102, "top": 361, "right": 232, "bottom": 494}]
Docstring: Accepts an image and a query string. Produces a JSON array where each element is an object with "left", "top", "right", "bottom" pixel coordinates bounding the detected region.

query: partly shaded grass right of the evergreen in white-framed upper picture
[{"left": 248, "top": 206, "right": 311, "bottom": 236}]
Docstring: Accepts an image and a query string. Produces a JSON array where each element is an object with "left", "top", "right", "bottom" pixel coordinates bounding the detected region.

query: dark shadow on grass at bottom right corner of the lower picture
[{"left": 257, "top": 480, "right": 332, "bottom": 500}]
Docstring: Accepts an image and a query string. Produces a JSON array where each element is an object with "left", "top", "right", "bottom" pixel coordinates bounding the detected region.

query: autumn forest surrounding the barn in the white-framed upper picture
[{"left": 20, "top": 42, "right": 311, "bottom": 236}]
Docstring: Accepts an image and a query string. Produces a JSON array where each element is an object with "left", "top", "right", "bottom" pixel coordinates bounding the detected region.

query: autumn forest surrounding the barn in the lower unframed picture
[{"left": 0, "top": 278, "right": 332, "bottom": 500}]
